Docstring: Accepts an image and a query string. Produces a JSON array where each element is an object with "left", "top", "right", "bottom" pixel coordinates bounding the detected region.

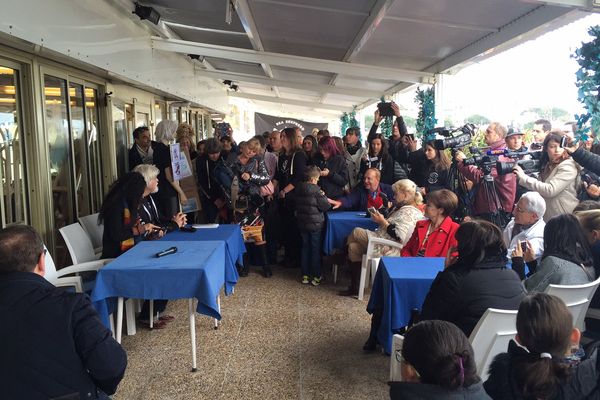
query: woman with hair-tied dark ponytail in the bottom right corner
[{"left": 484, "top": 293, "right": 600, "bottom": 400}]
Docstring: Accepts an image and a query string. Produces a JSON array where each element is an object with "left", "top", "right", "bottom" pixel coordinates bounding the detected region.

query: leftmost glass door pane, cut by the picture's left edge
[{"left": 0, "top": 61, "right": 29, "bottom": 227}]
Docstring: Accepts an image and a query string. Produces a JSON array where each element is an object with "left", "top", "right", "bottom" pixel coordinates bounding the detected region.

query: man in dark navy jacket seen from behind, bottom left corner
[{"left": 0, "top": 225, "right": 127, "bottom": 400}]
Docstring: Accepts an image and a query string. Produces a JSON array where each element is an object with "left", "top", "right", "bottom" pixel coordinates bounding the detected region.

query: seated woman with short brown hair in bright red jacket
[{"left": 400, "top": 189, "right": 458, "bottom": 257}]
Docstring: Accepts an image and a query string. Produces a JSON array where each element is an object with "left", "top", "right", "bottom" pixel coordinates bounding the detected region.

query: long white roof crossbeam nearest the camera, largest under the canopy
[{"left": 152, "top": 37, "right": 433, "bottom": 83}]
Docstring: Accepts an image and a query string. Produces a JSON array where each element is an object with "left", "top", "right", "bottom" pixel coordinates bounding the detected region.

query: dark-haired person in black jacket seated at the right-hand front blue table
[{"left": 421, "top": 220, "right": 527, "bottom": 336}]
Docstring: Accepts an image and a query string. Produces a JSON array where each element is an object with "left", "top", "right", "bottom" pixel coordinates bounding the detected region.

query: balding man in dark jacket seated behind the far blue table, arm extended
[{"left": 329, "top": 168, "right": 394, "bottom": 211}]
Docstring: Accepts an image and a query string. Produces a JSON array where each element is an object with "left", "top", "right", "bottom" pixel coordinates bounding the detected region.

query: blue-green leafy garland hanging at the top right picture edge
[{"left": 573, "top": 25, "right": 600, "bottom": 141}]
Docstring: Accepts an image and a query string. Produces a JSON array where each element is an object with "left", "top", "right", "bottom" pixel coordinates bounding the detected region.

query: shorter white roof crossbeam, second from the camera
[{"left": 196, "top": 69, "right": 382, "bottom": 98}]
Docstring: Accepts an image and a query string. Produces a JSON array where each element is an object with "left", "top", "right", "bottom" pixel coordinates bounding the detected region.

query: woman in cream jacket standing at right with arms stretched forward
[{"left": 513, "top": 131, "right": 580, "bottom": 221}]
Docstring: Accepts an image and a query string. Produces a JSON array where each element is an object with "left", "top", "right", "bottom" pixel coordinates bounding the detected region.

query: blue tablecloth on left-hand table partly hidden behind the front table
[{"left": 160, "top": 224, "right": 246, "bottom": 295}]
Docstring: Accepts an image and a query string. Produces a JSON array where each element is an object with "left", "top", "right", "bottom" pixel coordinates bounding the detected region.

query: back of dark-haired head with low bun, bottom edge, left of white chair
[{"left": 390, "top": 320, "right": 490, "bottom": 400}]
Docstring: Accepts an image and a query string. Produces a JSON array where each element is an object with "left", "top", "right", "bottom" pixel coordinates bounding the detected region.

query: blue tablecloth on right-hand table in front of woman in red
[{"left": 367, "top": 257, "right": 444, "bottom": 354}]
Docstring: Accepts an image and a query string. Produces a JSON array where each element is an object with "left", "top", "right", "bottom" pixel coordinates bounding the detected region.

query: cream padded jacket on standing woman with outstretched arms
[{"left": 519, "top": 158, "right": 581, "bottom": 222}]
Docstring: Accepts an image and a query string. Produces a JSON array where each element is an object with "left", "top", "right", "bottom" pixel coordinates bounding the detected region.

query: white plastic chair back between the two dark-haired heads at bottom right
[{"left": 469, "top": 308, "right": 517, "bottom": 382}]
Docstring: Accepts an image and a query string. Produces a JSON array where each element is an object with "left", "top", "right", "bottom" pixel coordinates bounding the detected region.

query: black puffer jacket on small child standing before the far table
[{"left": 293, "top": 182, "right": 331, "bottom": 232}]
